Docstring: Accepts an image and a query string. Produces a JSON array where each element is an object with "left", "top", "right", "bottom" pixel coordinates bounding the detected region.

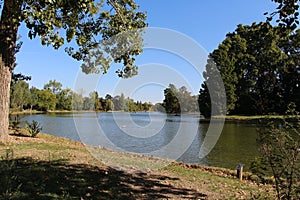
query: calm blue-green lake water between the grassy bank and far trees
[{"left": 21, "top": 113, "right": 258, "bottom": 169}]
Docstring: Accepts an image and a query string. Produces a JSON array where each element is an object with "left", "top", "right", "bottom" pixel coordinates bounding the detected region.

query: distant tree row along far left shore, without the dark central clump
[{"left": 10, "top": 80, "right": 153, "bottom": 112}]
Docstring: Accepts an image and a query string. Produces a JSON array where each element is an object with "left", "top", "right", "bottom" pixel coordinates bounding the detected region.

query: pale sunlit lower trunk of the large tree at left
[{"left": 0, "top": 57, "right": 11, "bottom": 143}]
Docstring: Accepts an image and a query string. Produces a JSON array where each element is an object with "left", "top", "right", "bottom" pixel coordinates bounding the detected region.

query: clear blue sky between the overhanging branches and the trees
[{"left": 15, "top": 0, "right": 276, "bottom": 103}]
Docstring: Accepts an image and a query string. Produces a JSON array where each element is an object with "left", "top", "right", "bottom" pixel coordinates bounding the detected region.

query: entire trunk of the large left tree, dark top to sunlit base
[{"left": 0, "top": 0, "right": 22, "bottom": 143}]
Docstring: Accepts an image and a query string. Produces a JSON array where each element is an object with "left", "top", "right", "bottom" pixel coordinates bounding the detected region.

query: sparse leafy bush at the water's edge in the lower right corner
[{"left": 252, "top": 105, "right": 300, "bottom": 200}]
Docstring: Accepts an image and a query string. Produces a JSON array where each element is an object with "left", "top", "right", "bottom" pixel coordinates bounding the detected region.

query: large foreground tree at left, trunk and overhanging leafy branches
[{"left": 0, "top": 0, "right": 146, "bottom": 142}]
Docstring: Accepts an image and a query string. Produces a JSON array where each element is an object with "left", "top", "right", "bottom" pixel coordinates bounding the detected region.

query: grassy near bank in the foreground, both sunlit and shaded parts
[{"left": 0, "top": 134, "right": 274, "bottom": 199}]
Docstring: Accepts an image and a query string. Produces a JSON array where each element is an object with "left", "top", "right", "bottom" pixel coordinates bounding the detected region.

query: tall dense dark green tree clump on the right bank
[{"left": 199, "top": 22, "right": 300, "bottom": 116}]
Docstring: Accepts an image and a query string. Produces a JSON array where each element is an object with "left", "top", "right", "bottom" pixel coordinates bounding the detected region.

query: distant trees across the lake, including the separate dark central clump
[{"left": 10, "top": 78, "right": 199, "bottom": 114}]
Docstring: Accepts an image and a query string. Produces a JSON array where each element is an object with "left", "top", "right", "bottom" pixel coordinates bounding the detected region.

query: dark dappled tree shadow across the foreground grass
[{"left": 0, "top": 158, "right": 206, "bottom": 199}]
